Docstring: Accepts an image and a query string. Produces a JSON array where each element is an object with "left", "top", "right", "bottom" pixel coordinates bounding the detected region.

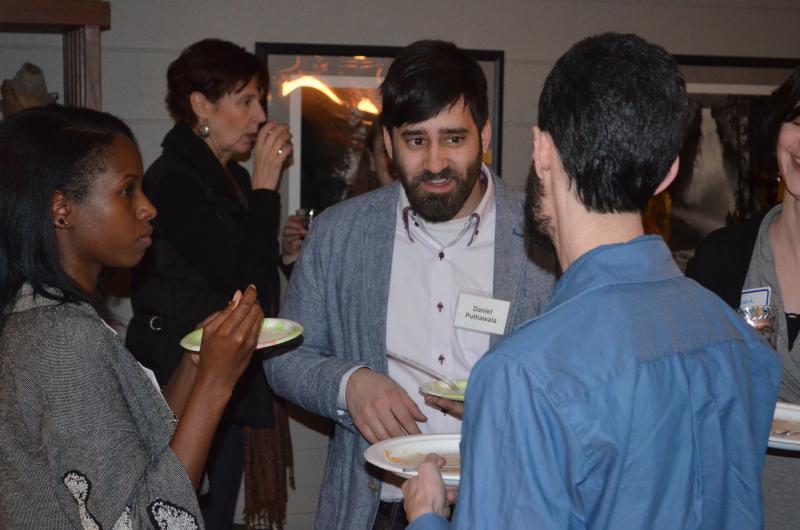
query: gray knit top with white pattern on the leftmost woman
[{"left": 0, "top": 285, "right": 203, "bottom": 530}]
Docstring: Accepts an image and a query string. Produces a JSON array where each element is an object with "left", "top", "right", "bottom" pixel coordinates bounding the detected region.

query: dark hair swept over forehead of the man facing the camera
[{"left": 381, "top": 40, "right": 489, "bottom": 131}]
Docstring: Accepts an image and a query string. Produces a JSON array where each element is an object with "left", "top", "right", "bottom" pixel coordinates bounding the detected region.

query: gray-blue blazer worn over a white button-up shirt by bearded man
[{"left": 265, "top": 177, "right": 555, "bottom": 530}]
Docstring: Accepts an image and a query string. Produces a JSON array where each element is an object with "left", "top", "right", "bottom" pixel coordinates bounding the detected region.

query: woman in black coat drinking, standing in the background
[{"left": 126, "top": 39, "right": 292, "bottom": 529}]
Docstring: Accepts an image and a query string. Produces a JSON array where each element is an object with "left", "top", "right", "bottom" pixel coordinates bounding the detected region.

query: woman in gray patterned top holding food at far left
[{"left": 0, "top": 106, "right": 263, "bottom": 529}]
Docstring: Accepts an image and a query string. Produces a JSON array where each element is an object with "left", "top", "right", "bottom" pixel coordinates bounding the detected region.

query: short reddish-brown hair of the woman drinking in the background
[{"left": 167, "top": 39, "right": 269, "bottom": 127}]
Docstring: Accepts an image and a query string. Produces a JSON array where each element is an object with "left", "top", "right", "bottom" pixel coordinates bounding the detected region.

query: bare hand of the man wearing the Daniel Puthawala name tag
[{"left": 345, "top": 368, "right": 428, "bottom": 444}]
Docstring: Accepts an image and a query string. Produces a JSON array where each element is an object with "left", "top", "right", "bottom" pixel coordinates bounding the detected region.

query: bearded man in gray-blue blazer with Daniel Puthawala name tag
[{"left": 265, "top": 41, "right": 554, "bottom": 529}]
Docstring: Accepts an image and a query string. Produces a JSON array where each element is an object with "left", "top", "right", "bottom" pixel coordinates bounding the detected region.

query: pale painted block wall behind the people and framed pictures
[{"left": 0, "top": 0, "right": 800, "bottom": 530}]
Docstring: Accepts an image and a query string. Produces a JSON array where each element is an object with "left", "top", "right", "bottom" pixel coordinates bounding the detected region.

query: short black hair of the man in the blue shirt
[{"left": 539, "top": 33, "right": 687, "bottom": 213}]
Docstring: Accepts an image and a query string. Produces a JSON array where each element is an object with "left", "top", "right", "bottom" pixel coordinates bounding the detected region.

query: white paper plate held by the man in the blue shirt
[{"left": 364, "top": 434, "right": 461, "bottom": 486}]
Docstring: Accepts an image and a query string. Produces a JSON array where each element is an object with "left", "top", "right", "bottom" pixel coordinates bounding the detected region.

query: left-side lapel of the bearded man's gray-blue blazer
[{"left": 361, "top": 183, "right": 400, "bottom": 373}]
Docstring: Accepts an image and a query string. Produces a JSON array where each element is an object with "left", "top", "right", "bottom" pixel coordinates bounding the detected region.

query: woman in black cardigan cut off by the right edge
[{"left": 686, "top": 67, "right": 800, "bottom": 530}]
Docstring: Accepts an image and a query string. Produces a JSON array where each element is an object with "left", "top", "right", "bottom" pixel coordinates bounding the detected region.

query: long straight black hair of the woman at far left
[{"left": 0, "top": 105, "right": 135, "bottom": 328}]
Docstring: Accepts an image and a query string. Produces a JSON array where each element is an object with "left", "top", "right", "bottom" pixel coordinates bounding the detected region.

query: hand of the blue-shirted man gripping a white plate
[{"left": 402, "top": 453, "right": 455, "bottom": 523}]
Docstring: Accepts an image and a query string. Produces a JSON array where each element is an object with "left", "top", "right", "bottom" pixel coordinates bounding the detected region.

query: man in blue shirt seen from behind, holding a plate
[{"left": 403, "top": 34, "right": 780, "bottom": 530}]
